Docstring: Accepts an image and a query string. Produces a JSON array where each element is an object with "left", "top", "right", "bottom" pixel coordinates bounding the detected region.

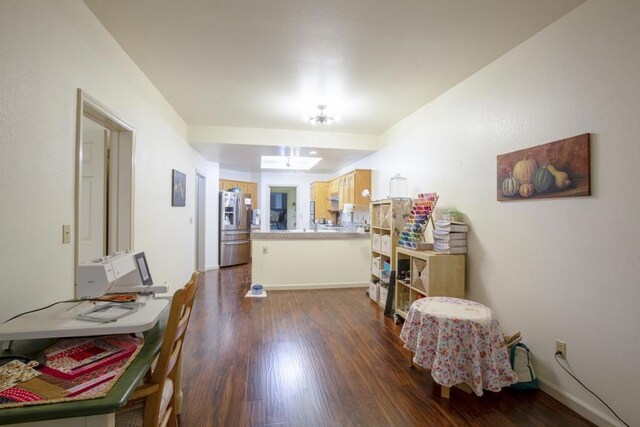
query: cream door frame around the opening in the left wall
[{"left": 73, "top": 89, "right": 135, "bottom": 283}]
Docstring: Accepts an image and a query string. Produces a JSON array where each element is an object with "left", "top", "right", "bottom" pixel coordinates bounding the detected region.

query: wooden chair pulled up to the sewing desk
[{"left": 116, "top": 271, "right": 200, "bottom": 427}]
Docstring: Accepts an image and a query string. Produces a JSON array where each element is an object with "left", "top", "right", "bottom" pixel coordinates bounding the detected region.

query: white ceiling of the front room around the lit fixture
[{"left": 85, "top": 0, "right": 583, "bottom": 172}]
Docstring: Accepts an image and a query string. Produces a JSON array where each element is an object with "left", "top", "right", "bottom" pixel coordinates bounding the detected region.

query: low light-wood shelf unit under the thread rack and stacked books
[{"left": 394, "top": 246, "right": 465, "bottom": 319}]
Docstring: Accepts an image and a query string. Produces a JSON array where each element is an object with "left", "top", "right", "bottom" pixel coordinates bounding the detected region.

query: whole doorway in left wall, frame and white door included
[{"left": 74, "top": 89, "right": 134, "bottom": 282}]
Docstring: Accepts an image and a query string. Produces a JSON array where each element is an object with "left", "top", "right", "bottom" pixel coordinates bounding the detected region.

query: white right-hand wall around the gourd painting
[{"left": 350, "top": 0, "right": 640, "bottom": 425}]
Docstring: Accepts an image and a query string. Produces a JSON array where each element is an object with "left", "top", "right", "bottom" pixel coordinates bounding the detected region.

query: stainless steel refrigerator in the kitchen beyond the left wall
[{"left": 218, "top": 191, "right": 251, "bottom": 267}]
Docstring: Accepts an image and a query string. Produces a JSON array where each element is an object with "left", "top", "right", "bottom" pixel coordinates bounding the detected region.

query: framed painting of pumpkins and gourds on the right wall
[{"left": 497, "top": 133, "right": 591, "bottom": 202}]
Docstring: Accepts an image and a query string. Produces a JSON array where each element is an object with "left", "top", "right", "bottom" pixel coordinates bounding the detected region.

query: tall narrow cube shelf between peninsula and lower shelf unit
[{"left": 371, "top": 199, "right": 411, "bottom": 307}]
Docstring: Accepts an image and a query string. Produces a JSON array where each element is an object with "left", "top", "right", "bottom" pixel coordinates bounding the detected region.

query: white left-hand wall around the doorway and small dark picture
[{"left": 0, "top": 0, "right": 206, "bottom": 318}]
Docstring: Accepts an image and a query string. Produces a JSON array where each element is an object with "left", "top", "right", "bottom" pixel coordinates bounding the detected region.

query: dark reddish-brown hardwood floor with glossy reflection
[{"left": 181, "top": 266, "right": 593, "bottom": 427}]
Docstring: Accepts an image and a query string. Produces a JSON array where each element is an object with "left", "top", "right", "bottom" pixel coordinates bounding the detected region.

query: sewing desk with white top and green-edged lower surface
[{"left": 0, "top": 299, "right": 169, "bottom": 427}]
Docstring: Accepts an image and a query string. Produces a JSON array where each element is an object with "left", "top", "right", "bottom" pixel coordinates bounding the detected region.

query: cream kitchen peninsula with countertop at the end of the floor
[{"left": 251, "top": 230, "right": 371, "bottom": 290}]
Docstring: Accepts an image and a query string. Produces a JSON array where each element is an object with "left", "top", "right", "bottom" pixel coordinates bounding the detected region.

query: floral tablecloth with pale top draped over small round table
[{"left": 400, "top": 297, "right": 518, "bottom": 396}]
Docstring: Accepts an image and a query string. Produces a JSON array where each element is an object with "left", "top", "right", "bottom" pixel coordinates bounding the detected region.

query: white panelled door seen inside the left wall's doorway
[{"left": 78, "top": 117, "right": 108, "bottom": 262}]
